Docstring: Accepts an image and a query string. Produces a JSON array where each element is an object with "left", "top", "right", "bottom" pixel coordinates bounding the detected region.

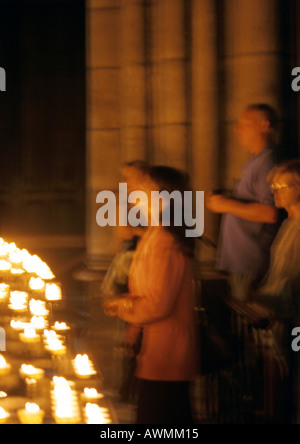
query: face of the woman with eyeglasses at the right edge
[{"left": 271, "top": 173, "right": 299, "bottom": 210}]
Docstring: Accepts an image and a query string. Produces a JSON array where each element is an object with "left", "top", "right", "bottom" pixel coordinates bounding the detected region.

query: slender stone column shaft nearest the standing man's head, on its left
[{"left": 190, "top": 0, "right": 219, "bottom": 262}]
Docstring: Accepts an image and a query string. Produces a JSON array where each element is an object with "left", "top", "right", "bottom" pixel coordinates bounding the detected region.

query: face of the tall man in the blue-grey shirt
[{"left": 236, "top": 110, "right": 263, "bottom": 153}]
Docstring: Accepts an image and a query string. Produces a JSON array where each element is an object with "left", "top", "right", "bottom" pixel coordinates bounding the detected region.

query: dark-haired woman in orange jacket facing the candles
[{"left": 105, "top": 166, "right": 197, "bottom": 424}]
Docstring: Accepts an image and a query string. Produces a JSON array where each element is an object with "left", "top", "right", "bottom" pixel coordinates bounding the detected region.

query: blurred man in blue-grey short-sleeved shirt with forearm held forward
[{"left": 206, "top": 104, "right": 279, "bottom": 301}]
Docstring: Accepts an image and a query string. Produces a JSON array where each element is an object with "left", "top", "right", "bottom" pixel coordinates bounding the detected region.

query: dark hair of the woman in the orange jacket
[{"left": 148, "top": 165, "right": 195, "bottom": 257}]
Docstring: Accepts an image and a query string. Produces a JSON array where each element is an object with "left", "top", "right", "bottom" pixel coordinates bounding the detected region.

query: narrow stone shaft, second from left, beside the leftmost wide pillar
[{"left": 121, "top": 0, "right": 147, "bottom": 161}]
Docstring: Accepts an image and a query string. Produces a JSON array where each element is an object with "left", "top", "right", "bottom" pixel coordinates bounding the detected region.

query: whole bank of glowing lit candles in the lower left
[{"left": 0, "top": 238, "right": 111, "bottom": 424}]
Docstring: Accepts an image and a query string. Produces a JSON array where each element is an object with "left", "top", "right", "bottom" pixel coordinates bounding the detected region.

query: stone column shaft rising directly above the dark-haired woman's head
[{"left": 151, "top": 0, "right": 188, "bottom": 169}]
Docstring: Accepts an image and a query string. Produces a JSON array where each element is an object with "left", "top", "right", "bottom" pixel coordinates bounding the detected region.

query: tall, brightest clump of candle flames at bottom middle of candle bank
[{"left": 51, "top": 376, "right": 81, "bottom": 424}]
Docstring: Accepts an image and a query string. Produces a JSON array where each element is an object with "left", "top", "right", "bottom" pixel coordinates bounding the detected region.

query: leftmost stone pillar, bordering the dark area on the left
[{"left": 82, "top": 0, "right": 121, "bottom": 276}]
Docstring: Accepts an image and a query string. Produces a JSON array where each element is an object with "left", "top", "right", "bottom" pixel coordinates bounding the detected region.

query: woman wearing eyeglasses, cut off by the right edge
[{"left": 248, "top": 159, "right": 300, "bottom": 424}]
